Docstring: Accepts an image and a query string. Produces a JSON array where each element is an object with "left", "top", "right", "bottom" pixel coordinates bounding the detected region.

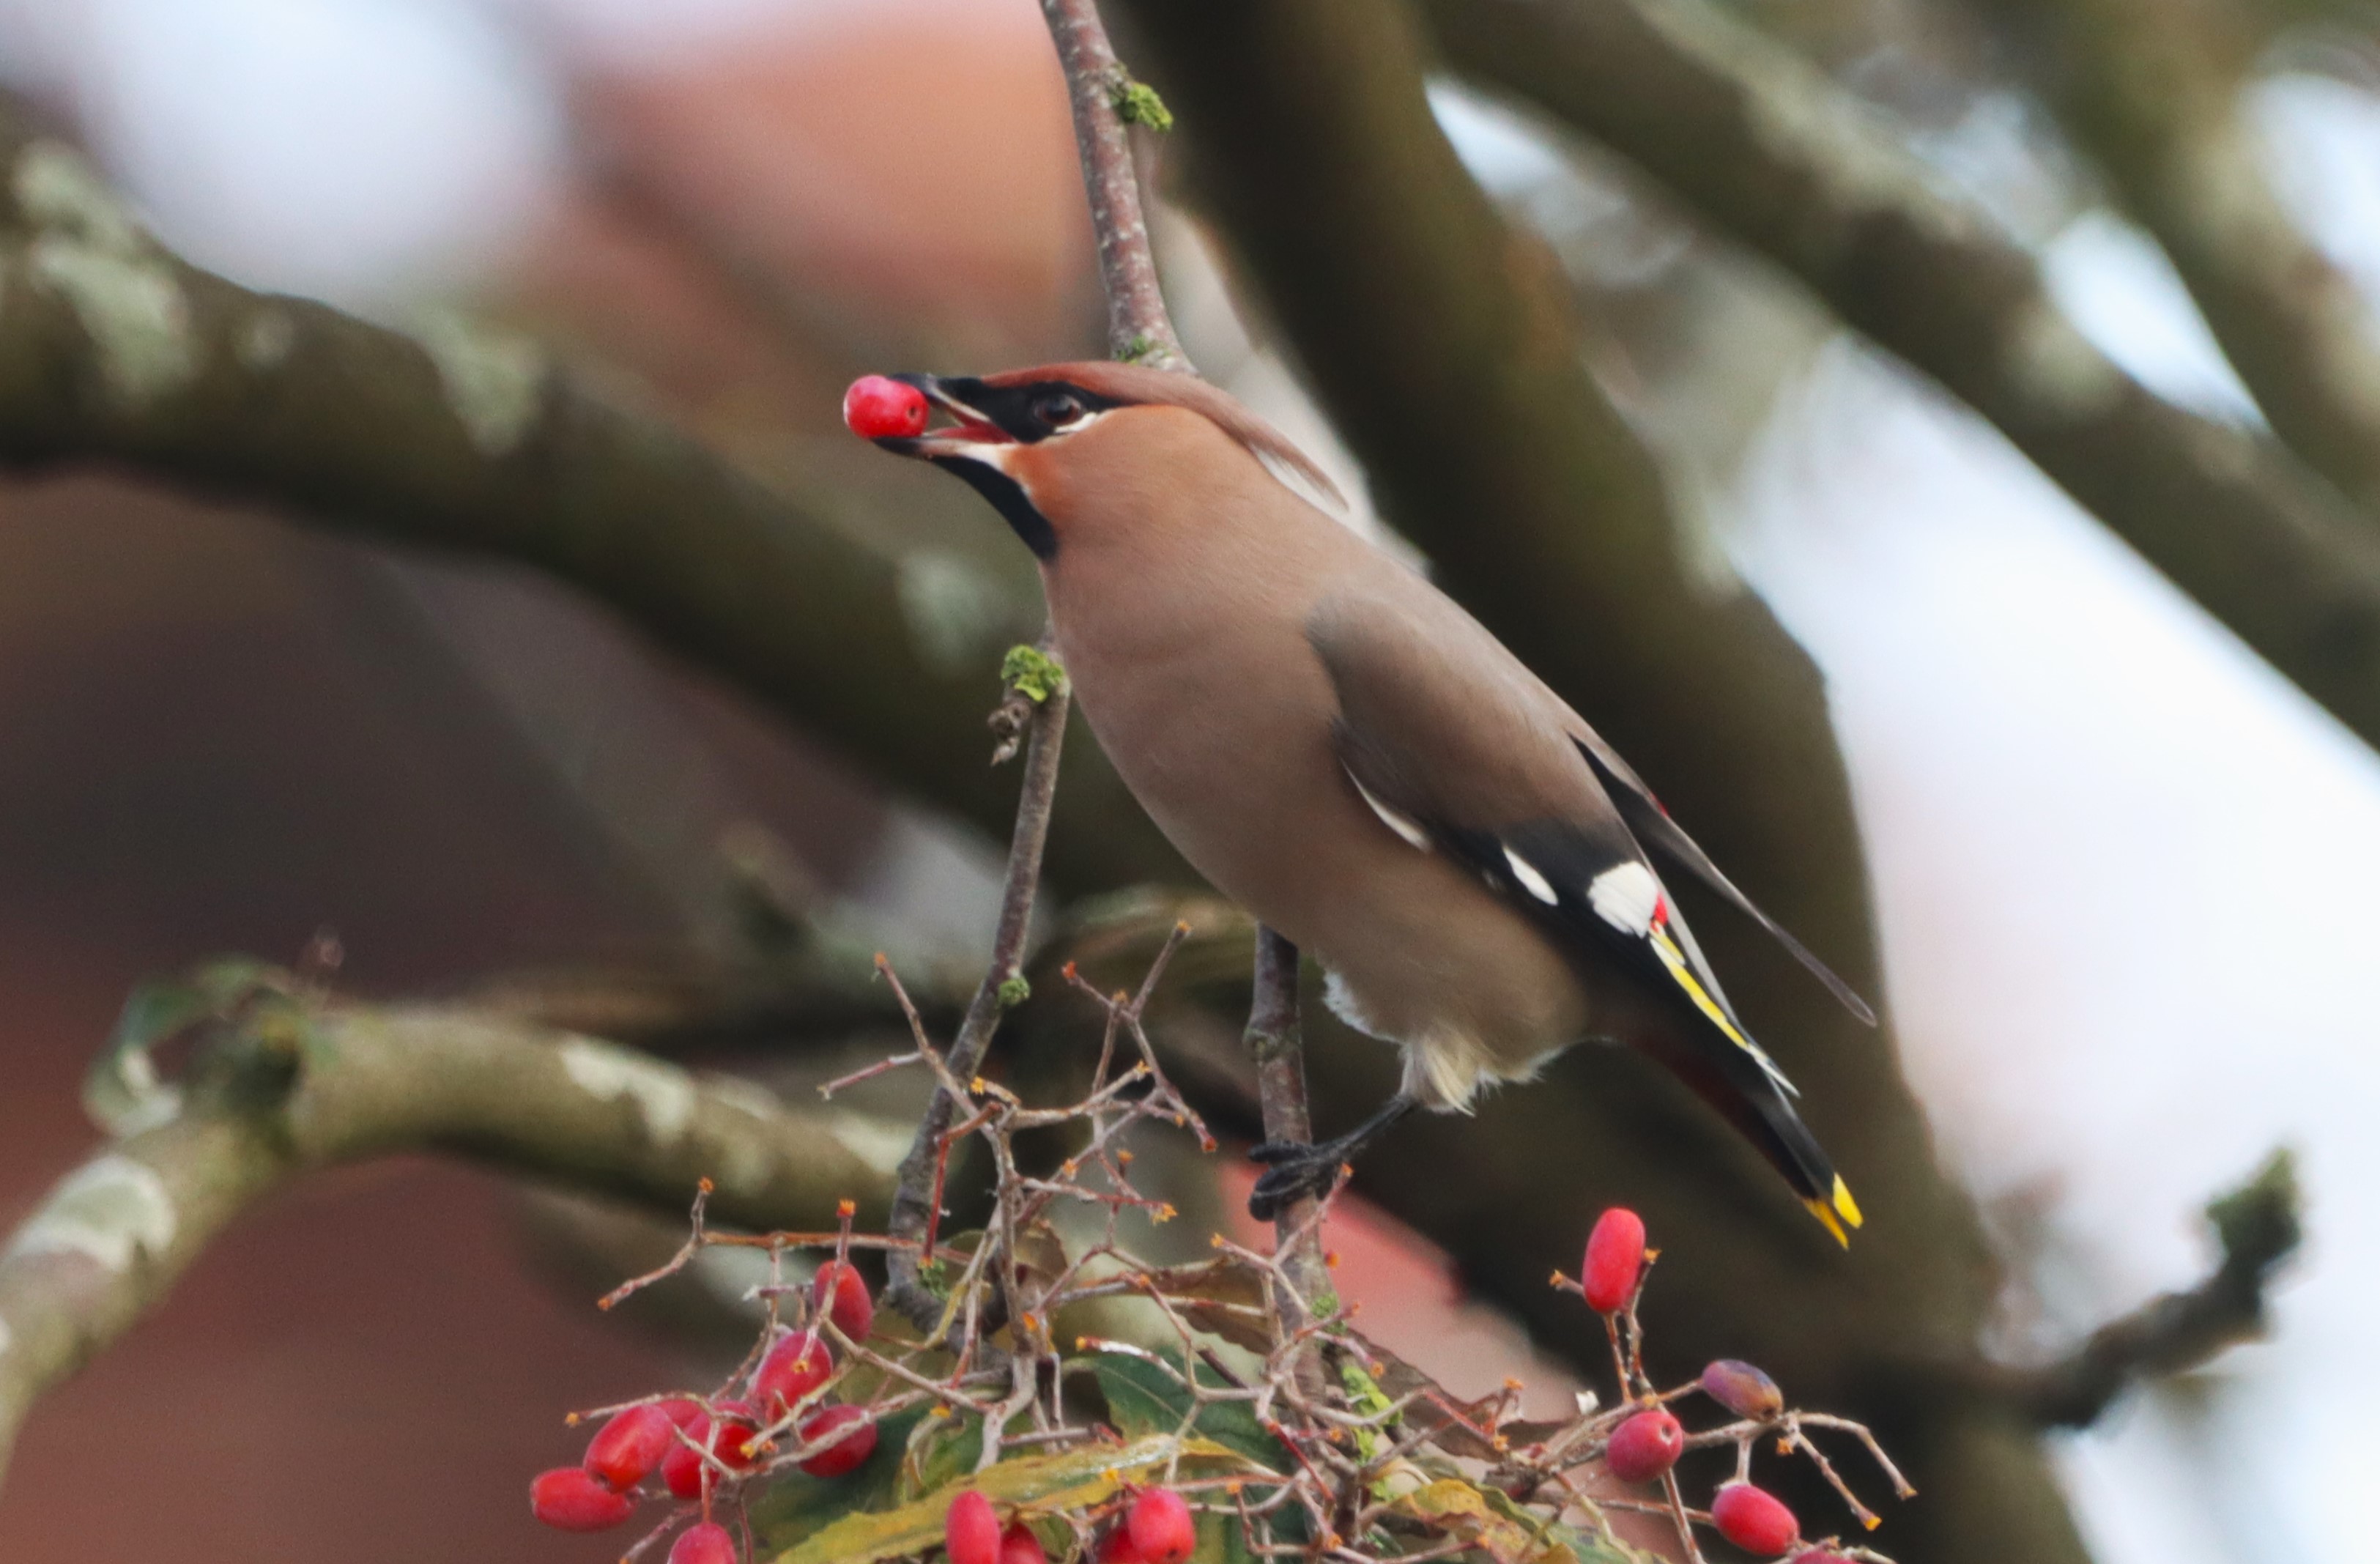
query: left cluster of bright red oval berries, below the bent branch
[{"left": 528, "top": 1259, "right": 885, "bottom": 1564}]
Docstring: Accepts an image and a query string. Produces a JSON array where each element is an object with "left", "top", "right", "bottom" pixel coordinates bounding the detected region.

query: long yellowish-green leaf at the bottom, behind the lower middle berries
[{"left": 752, "top": 1438, "right": 1247, "bottom": 1564}]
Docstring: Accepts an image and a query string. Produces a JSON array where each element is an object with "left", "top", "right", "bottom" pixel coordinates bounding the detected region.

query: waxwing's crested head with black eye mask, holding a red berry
[{"left": 842, "top": 362, "right": 1342, "bottom": 562}]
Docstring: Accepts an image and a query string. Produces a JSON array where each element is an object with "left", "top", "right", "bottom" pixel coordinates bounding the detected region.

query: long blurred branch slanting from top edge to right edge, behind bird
[{"left": 1428, "top": 0, "right": 2380, "bottom": 745}]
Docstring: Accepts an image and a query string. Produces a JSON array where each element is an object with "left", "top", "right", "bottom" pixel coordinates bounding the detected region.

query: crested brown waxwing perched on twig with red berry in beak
[{"left": 845, "top": 362, "right": 1875, "bottom": 1245}]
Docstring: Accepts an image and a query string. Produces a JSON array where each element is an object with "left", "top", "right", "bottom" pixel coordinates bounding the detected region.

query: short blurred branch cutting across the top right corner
[{"left": 1992, "top": 0, "right": 2380, "bottom": 526}]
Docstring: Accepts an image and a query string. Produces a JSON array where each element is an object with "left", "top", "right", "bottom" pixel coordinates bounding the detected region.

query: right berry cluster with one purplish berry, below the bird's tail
[{"left": 1554, "top": 1207, "right": 1873, "bottom": 1564}]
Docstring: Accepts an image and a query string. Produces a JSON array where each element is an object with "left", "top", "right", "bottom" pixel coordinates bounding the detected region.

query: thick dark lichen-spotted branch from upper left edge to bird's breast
[{"left": 0, "top": 105, "right": 1183, "bottom": 888}]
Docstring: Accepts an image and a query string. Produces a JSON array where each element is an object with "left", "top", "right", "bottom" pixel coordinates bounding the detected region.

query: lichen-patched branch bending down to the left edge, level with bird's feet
[{"left": 0, "top": 983, "right": 888, "bottom": 1469}]
